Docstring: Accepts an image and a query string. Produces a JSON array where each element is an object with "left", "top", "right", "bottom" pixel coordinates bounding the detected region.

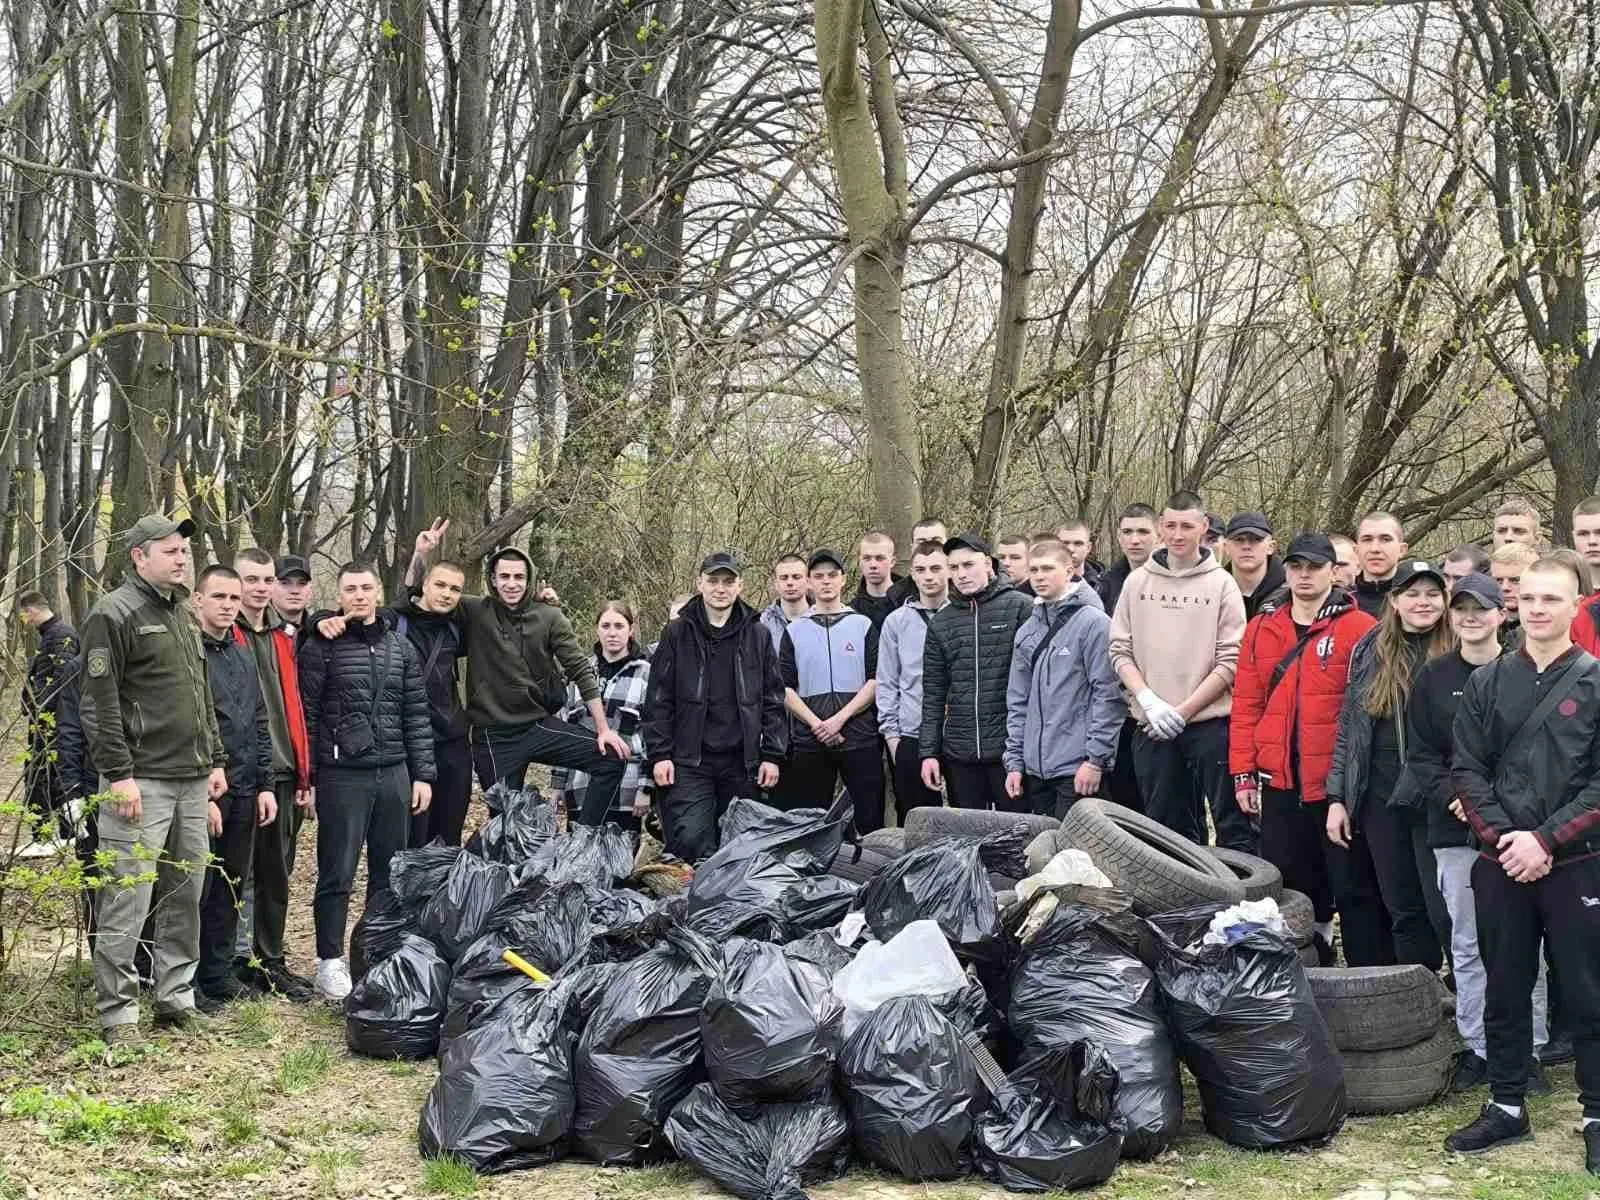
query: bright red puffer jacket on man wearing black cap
[{"left": 1227, "top": 589, "right": 1378, "bottom": 803}]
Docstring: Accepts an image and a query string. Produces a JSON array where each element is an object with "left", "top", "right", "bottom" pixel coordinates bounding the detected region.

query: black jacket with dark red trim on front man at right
[{"left": 1451, "top": 646, "right": 1600, "bottom": 864}]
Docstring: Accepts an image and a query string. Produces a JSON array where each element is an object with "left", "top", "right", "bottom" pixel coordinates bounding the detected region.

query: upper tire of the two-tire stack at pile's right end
[{"left": 1306, "top": 963, "right": 1445, "bottom": 1053}]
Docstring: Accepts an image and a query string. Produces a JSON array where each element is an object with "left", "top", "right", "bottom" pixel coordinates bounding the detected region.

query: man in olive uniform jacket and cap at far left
[{"left": 82, "top": 514, "right": 227, "bottom": 1045}]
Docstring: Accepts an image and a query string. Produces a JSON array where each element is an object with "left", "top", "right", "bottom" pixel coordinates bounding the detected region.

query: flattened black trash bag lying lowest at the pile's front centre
[{"left": 667, "top": 1083, "right": 850, "bottom": 1200}]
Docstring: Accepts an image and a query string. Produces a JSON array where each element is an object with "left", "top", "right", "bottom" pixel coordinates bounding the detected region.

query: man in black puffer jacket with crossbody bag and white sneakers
[{"left": 299, "top": 563, "right": 434, "bottom": 1000}]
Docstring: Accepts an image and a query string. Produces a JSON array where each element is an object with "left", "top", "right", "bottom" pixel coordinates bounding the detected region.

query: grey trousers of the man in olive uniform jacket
[{"left": 94, "top": 776, "right": 211, "bottom": 1029}]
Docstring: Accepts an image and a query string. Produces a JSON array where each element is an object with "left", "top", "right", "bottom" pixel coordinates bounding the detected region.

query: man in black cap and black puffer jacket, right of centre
[{"left": 917, "top": 533, "right": 1034, "bottom": 813}]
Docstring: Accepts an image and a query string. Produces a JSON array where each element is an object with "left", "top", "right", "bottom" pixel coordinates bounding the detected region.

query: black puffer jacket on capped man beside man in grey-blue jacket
[{"left": 917, "top": 579, "right": 1034, "bottom": 763}]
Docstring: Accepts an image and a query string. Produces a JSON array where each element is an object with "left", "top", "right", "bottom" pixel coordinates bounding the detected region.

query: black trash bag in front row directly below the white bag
[{"left": 838, "top": 995, "right": 987, "bottom": 1179}]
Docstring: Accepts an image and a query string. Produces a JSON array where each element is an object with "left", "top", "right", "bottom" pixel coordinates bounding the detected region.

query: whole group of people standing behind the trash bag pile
[{"left": 21, "top": 491, "right": 1600, "bottom": 1170}]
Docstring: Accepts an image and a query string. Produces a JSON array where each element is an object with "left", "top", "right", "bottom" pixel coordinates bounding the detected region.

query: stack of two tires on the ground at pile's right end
[{"left": 1306, "top": 965, "right": 1461, "bottom": 1115}]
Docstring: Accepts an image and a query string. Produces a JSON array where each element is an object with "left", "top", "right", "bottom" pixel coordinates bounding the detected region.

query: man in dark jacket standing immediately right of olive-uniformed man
[{"left": 195, "top": 566, "right": 278, "bottom": 1011}]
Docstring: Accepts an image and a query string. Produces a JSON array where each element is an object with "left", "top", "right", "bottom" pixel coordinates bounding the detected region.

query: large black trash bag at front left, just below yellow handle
[{"left": 416, "top": 978, "right": 595, "bottom": 1174}]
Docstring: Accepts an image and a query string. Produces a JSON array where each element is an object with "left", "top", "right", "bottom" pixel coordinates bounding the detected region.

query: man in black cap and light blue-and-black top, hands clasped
[{"left": 778, "top": 550, "right": 883, "bottom": 834}]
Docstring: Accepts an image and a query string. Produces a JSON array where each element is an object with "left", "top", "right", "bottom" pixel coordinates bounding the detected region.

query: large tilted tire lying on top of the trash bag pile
[{"left": 1061, "top": 798, "right": 1245, "bottom": 915}]
